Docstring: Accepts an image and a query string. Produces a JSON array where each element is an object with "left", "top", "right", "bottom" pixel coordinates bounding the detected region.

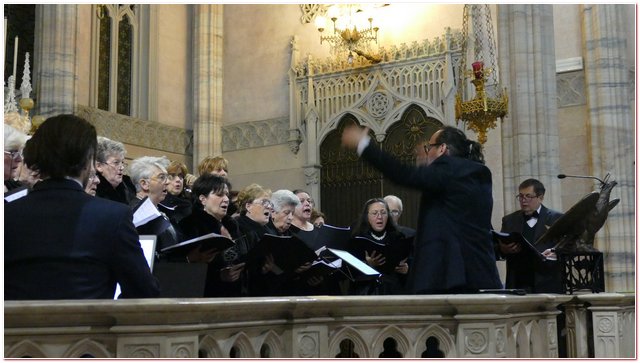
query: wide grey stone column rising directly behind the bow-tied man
[{"left": 497, "top": 4, "right": 562, "bottom": 213}]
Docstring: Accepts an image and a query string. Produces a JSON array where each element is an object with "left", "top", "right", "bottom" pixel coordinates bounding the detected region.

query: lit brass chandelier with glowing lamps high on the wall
[{"left": 316, "top": 4, "right": 385, "bottom": 64}]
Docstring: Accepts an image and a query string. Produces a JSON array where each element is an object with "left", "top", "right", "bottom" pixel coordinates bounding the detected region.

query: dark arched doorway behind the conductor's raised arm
[{"left": 320, "top": 105, "right": 442, "bottom": 228}]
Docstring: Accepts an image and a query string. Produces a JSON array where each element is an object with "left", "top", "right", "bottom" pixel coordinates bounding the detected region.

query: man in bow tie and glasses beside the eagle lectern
[{"left": 496, "top": 179, "right": 563, "bottom": 294}]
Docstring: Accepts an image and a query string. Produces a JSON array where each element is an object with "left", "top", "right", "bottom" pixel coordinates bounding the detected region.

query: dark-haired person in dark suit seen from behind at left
[{"left": 4, "top": 115, "right": 159, "bottom": 300}]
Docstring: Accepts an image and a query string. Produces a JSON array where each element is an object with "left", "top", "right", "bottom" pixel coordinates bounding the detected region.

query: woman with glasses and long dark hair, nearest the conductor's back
[{"left": 349, "top": 198, "right": 409, "bottom": 295}]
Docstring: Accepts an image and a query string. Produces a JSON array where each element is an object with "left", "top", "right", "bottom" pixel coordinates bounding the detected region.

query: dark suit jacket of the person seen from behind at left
[{"left": 4, "top": 179, "right": 159, "bottom": 300}]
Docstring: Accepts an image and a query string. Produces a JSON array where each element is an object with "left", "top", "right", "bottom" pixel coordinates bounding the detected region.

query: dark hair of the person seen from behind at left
[{"left": 24, "top": 114, "right": 98, "bottom": 178}]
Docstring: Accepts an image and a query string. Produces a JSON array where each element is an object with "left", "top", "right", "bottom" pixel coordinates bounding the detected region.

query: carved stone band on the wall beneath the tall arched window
[{"left": 76, "top": 105, "right": 193, "bottom": 155}]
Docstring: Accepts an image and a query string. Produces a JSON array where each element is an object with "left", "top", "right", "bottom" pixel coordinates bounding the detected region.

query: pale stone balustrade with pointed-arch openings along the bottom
[{"left": 4, "top": 293, "right": 635, "bottom": 358}]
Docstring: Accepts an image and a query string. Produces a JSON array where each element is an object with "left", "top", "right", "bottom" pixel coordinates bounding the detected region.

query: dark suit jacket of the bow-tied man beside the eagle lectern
[{"left": 496, "top": 205, "right": 563, "bottom": 293}]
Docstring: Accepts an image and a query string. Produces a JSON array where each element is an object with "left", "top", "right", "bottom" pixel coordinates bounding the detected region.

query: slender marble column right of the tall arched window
[{"left": 191, "top": 4, "right": 224, "bottom": 170}]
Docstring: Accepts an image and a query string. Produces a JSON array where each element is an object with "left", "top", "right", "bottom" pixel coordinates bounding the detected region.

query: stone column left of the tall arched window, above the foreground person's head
[{"left": 32, "top": 4, "right": 78, "bottom": 117}]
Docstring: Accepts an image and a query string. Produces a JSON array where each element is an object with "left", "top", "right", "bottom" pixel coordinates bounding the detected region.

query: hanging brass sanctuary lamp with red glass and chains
[{"left": 455, "top": 5, "right": 509, "bottom": 144}]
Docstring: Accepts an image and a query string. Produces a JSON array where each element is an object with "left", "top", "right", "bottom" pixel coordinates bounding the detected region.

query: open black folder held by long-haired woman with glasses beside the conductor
[{"left": 352, "top": 236, "right": 413, "bottom": 273}]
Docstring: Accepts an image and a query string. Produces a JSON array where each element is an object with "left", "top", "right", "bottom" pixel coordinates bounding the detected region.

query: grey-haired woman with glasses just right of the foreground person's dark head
[{"left": 96, "top": 136, "right": 136, "bottom": 205}]
